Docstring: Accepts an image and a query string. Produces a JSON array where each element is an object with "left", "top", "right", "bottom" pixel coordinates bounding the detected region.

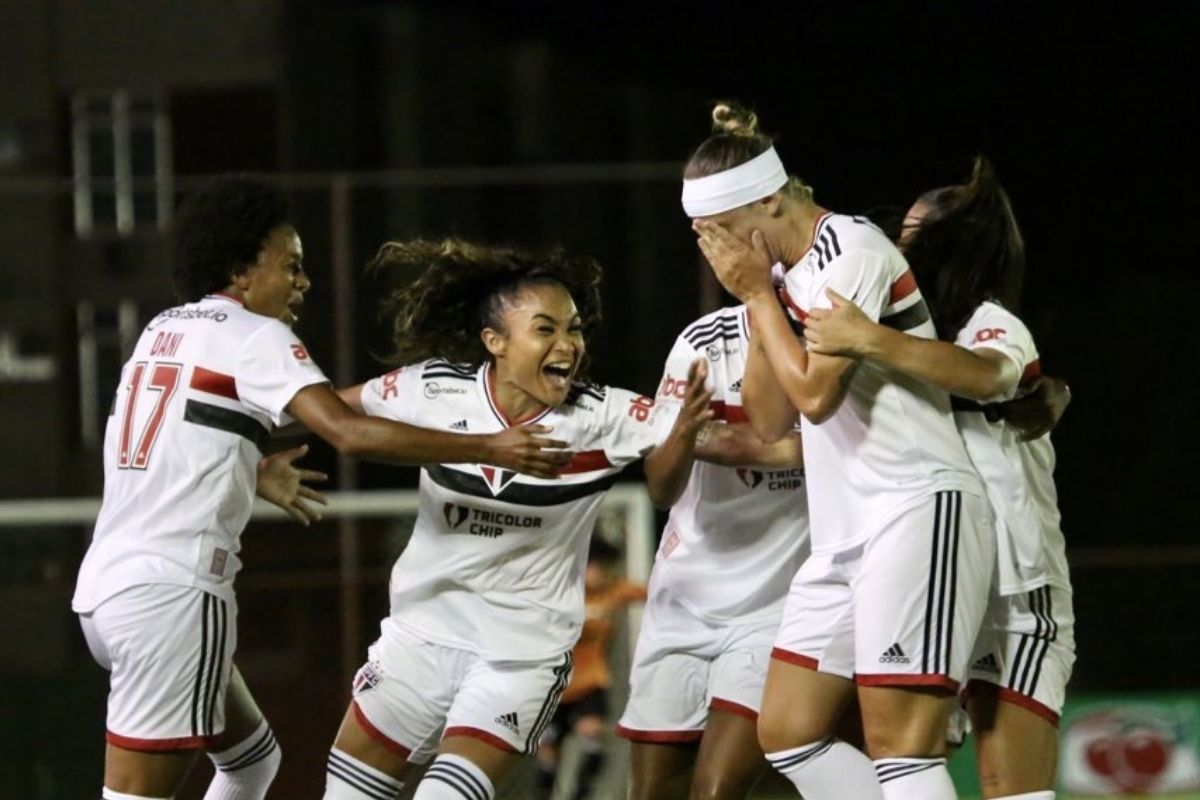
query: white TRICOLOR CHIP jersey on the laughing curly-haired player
[{"left": 362, "top": 360, "right": 670, "bottom": 661}]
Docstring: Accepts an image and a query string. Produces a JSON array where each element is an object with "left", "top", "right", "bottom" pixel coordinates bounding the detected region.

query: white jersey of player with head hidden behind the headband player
[{"left": 652, "top": 306, "right": 809, "bottom": 622}]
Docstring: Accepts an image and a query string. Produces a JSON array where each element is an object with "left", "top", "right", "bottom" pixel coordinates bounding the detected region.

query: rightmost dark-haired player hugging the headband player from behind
[{"left": 806, "top": 158, "right": 1075, "bottom": 800}]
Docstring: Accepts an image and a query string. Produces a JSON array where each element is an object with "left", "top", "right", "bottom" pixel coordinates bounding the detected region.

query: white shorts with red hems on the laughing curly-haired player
[{"left": 353, "top": 619, "right": 571, "bottom": 764}]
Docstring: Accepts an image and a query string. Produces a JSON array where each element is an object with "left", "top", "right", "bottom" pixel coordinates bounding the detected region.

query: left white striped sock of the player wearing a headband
[{"left": 767, "top": 739, "right": 888, "bottom": 800}]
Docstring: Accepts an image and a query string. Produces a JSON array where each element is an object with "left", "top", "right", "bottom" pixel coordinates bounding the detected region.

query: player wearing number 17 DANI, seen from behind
[{"left": 72, "top": 176, "right": 563, "bottom": 800}]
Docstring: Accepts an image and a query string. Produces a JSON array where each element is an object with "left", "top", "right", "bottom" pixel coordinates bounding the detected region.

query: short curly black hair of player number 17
[{"left": 169, "top": 175, "right": 290, "bottom": 302}]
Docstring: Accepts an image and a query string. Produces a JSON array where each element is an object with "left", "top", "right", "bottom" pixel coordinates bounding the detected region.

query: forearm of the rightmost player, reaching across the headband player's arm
[{"left": 863, "top": 324, "right": 1020, "bottom": 402}]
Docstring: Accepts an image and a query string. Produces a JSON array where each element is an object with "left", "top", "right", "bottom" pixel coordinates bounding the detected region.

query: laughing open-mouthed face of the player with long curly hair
[{"left": 481, "top": 283, "right": 584, "bottom": 420}]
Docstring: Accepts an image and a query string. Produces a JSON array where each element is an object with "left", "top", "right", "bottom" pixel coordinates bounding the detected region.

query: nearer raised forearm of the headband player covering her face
[{"left": 742, "top": 296, "right": 845, "bottom": 424}]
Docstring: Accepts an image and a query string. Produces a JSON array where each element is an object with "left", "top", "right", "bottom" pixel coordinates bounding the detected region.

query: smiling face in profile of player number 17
[{"left": 234, "top": 224, "right": 312, "bottom": 325}]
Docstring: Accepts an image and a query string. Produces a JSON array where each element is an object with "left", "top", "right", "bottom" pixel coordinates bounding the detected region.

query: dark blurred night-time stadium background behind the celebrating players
[{"left": 0, "top": 0, "right": 1200, "bottom": 800}]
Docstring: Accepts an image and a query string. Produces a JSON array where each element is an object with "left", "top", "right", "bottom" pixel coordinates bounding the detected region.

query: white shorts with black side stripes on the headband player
[{"left": 772, "top": 491, "right": 996, "bottom": 691}]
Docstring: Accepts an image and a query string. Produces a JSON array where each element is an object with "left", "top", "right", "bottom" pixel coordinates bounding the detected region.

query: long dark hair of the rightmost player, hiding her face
[{"left": 904, "top": 156, "right": 1025, "bottom": 342}]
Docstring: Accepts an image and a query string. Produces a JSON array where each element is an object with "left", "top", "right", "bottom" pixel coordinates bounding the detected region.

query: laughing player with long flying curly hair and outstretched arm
[{"left": 325, "top": 240, "right": 713, "bottom": 800}]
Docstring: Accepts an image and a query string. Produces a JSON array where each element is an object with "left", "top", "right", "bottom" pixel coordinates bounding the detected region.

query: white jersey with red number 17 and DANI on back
[{"left": 71, "top": 294, "right": 326, "bottom": 612}]
